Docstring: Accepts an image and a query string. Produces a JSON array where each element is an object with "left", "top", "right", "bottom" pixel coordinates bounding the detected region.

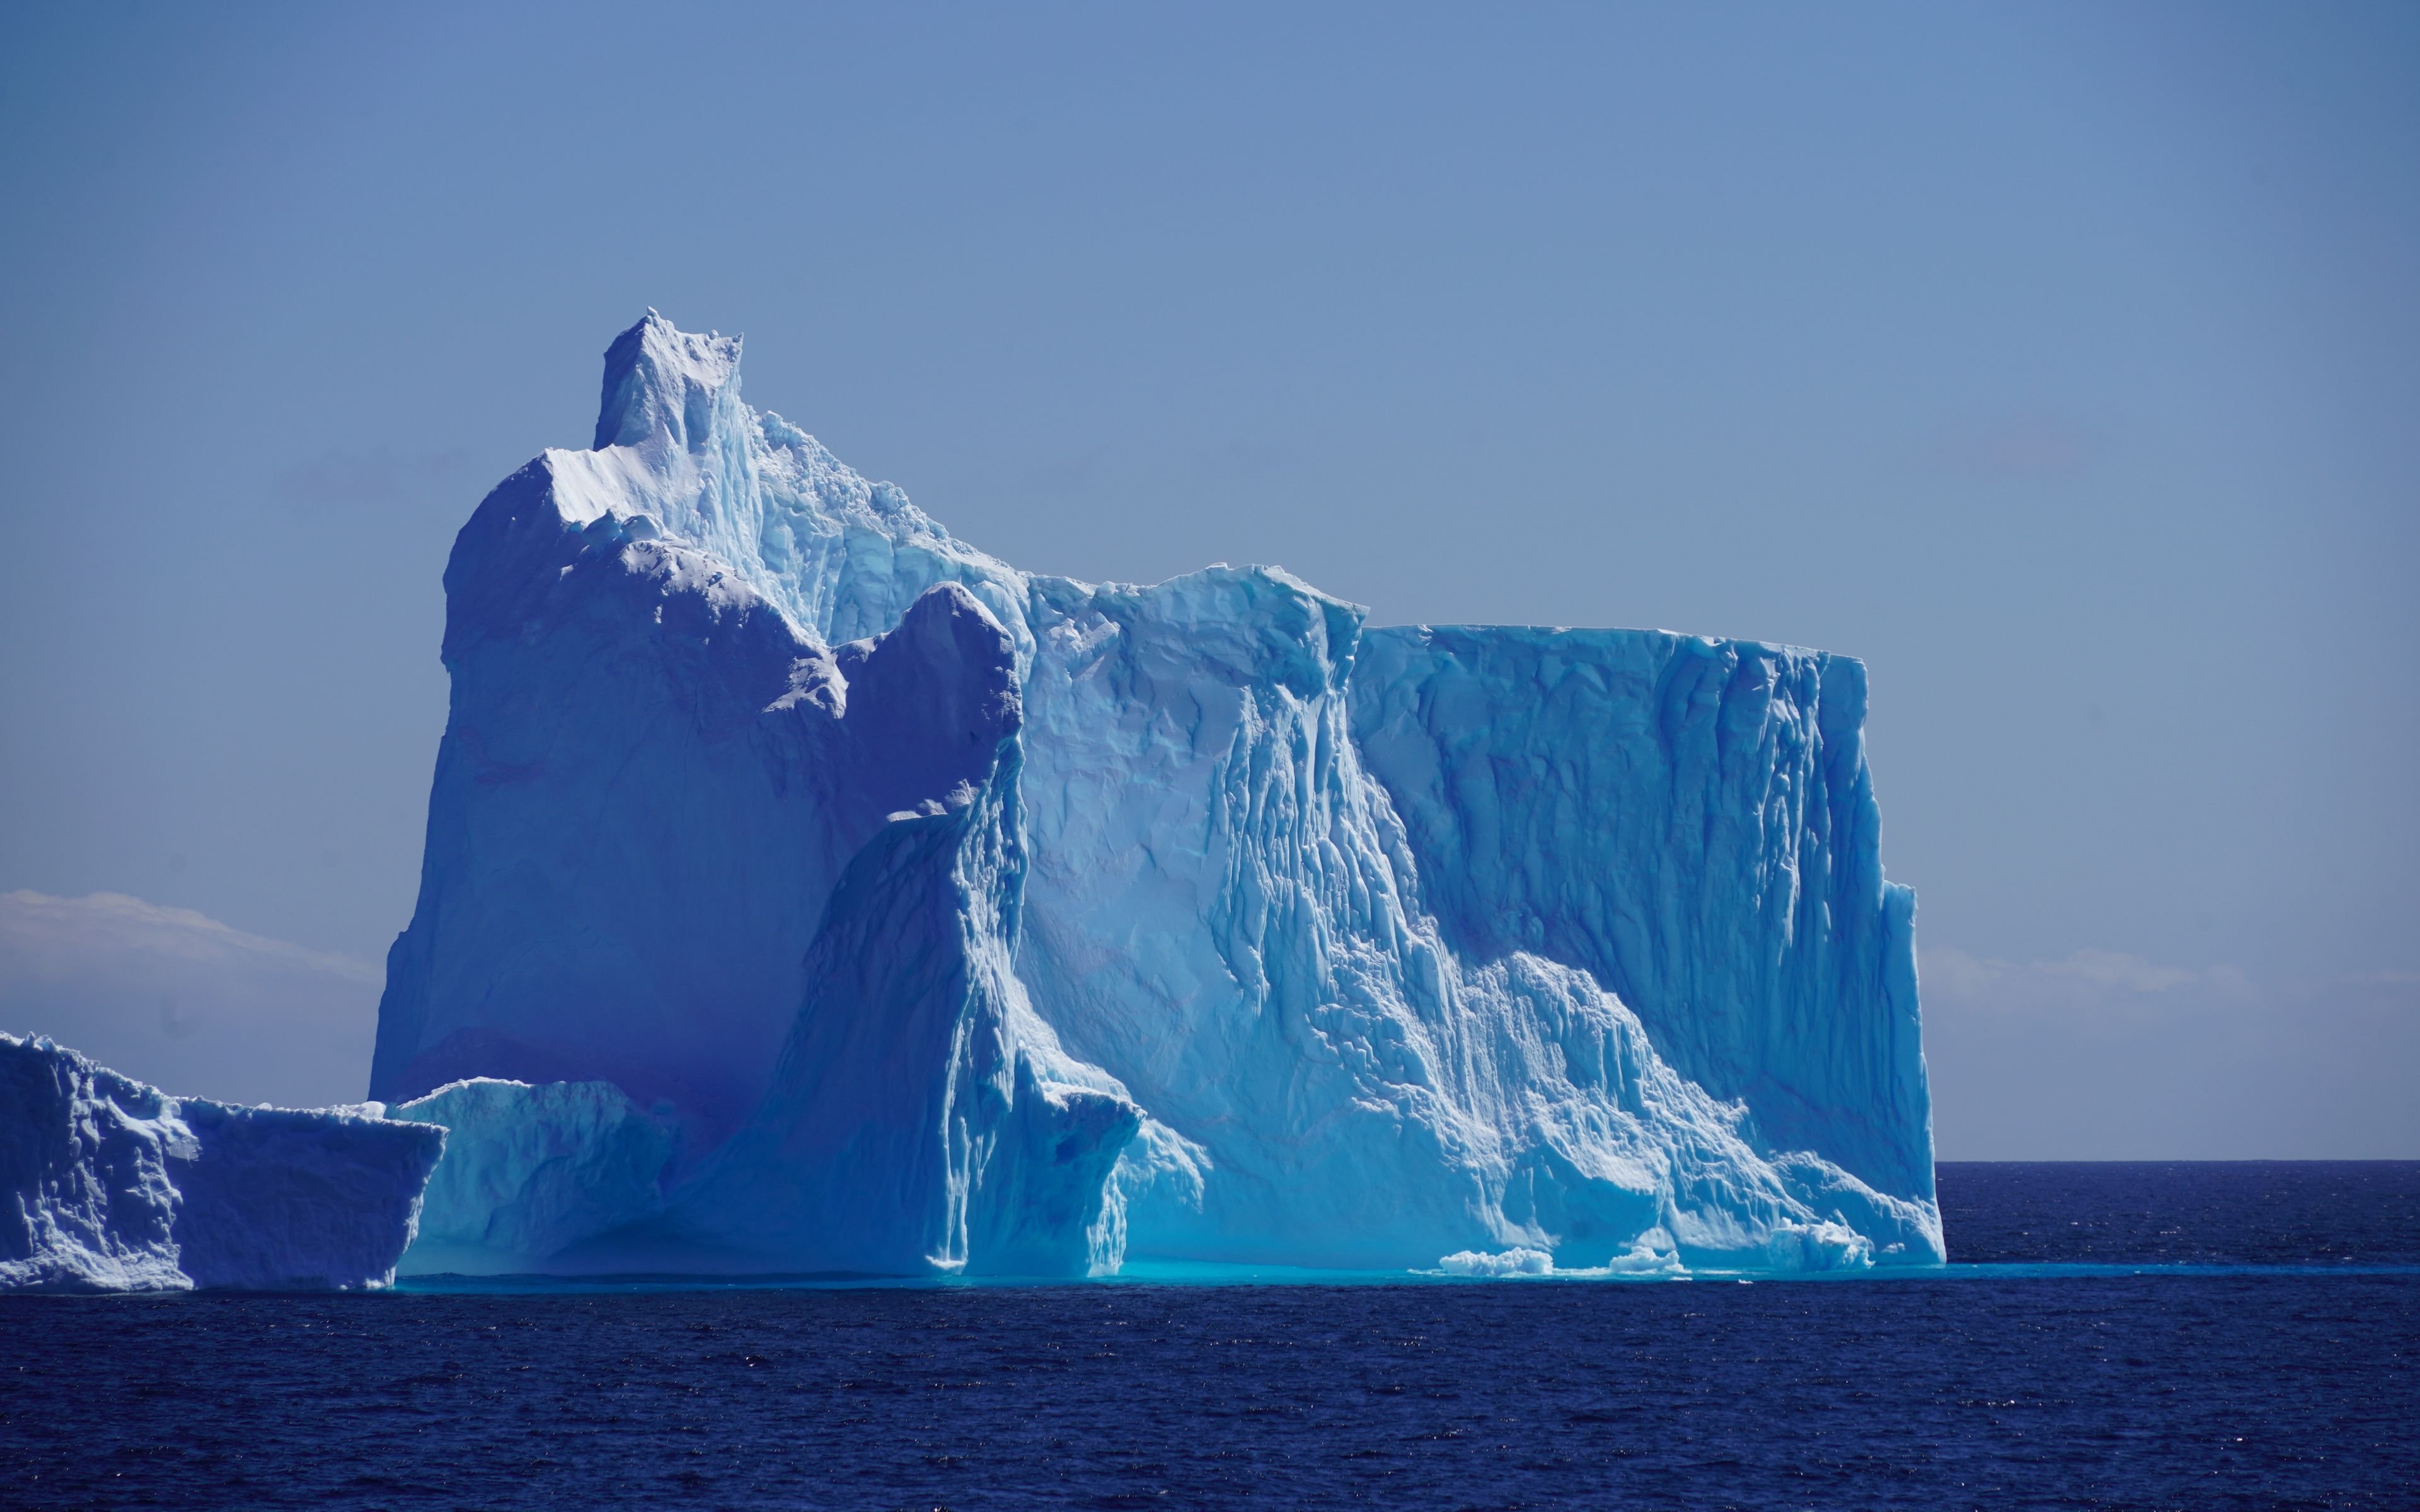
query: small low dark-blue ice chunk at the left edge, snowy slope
[{"left": 0, "top": 1033, "right": 446, "bottom": 1292}]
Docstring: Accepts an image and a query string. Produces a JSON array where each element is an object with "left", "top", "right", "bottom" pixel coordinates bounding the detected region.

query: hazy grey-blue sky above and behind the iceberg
[{"left": 0, "top": 5, "right": 2420, "bottom": 1159}]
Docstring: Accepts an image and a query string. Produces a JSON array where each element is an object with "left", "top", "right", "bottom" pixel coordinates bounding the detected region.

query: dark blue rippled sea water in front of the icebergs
[{"left": 0, "top": 1164, "right": 2420, "bottom": 1509}]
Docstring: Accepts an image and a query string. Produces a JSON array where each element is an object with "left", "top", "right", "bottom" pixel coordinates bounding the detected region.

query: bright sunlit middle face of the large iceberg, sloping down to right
[{"left": 1019, "top": 568, "right": 1939, "bottom": 1268}]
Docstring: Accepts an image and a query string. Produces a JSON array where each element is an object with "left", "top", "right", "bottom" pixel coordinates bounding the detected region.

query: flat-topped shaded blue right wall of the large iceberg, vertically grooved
[{"left": 1353, "top": 627, "right": 1933, "bottom": 1198}]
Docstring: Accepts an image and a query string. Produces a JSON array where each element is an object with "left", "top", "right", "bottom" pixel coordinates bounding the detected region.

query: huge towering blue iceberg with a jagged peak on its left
[{"left": 371, "top": 312, "right": 1941, "bottom": 1275}]
